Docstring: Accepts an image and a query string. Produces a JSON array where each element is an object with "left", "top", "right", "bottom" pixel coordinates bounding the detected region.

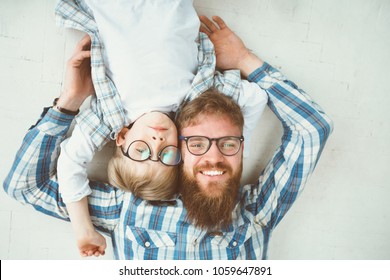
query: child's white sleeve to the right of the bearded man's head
[{"left": 238, "top": 80, "right": 268, "bottom": 157}]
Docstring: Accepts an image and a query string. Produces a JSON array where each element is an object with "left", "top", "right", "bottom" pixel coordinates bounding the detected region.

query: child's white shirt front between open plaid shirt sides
[{"left": 85, "top": 0, "right": 200, "bottom": 120}]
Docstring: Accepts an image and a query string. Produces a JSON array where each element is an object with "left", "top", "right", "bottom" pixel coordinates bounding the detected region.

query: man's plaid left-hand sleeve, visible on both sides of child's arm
[{"left": 3, "top": 109, "right": 123, "bottom": 232}]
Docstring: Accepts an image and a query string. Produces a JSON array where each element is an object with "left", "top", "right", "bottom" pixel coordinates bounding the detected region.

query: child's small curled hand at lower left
[{"left": 77, "top": 231, "right": 107, "bottom": 257}]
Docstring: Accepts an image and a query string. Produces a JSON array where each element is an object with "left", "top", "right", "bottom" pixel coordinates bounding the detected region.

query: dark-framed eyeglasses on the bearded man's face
[{"left": 179, "top": 136, "right": 244, "bottom": 156}]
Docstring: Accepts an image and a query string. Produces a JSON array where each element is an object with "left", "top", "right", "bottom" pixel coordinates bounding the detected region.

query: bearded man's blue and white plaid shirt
[{"left": 4, "top": 63, "right": 333, "bottom": 259}]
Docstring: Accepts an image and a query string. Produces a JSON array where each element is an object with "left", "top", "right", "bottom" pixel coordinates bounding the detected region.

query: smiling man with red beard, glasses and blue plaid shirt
[{"left": 4, "top": 17, "right": 333, "bottom": 259}]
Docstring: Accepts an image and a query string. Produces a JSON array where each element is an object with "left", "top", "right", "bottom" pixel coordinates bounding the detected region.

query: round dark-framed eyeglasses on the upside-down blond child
[{"left": 121, "top": 140, "right": 181, "bottom": 166}]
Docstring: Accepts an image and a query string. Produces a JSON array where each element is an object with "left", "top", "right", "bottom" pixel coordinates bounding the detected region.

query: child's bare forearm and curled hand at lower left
[{"left": 66, "top": 197, "right": 107, "bottom": 257}]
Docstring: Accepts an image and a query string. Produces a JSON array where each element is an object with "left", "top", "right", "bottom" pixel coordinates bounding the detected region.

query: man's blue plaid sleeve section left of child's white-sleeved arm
[{"left": 3, "top": 109, "right": 74, "bottom": 219}]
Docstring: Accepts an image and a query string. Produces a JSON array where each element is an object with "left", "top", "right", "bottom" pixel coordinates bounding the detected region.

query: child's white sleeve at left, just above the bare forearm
[{"left": 57, "top": 124, "right": 95, "bottom": 203}]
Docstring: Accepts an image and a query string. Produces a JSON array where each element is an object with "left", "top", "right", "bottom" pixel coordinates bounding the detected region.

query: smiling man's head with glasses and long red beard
[{"left": 177, "top": 91, "right": 244, "bottom": 231}]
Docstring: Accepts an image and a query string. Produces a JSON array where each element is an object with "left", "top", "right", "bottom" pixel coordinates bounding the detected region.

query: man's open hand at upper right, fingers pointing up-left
[{"left": 199, "top": 16, "right": 263, "bottom": 76}]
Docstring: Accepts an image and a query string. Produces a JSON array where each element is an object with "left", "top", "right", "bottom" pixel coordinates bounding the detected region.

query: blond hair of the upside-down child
[{"left": 108, "top": 147, "right": 179, "bottom": 201}]
